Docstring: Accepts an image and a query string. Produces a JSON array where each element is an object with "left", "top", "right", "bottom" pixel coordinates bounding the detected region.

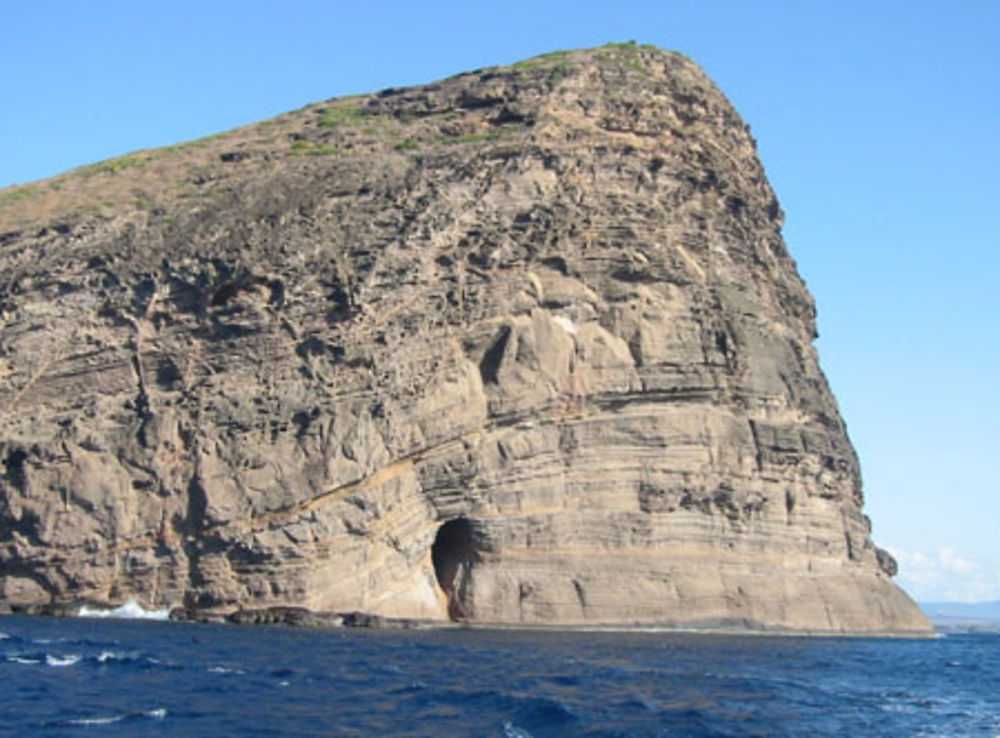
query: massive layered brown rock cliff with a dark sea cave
[{"left": 0, "top": 46, "right": 928, "bottom": 633}]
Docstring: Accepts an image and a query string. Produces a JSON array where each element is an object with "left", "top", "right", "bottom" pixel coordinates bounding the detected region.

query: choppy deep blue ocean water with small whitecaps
[{"left": 0, "top": 617, "right": 1000, "bottom": 738}]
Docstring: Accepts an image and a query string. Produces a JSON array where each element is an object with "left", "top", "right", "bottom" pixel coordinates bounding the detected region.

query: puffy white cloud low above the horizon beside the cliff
[{"left": 886, "top": 546, "right": 1000, "bottom": 602}]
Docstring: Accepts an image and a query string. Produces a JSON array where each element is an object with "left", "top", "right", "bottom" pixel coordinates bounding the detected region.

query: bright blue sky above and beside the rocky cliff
[{"left": 0, "top": 0, "right": 1000, "bottom": 600}]
